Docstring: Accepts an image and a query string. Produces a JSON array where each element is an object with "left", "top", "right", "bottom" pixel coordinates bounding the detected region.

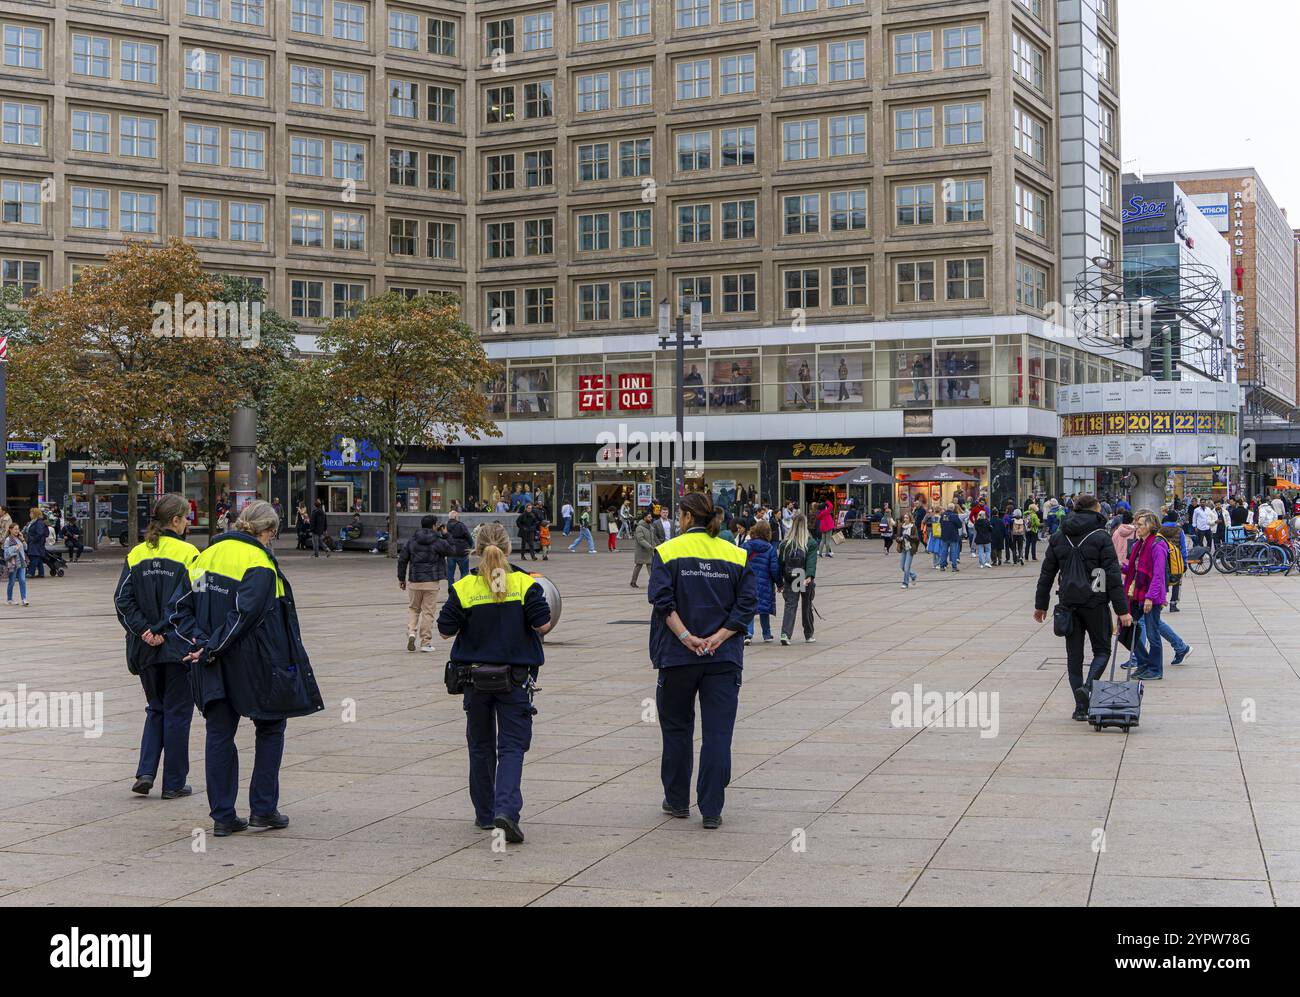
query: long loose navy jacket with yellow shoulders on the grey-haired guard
[{"left": 169, "top": 532, "right": 325, "bottom": 720}]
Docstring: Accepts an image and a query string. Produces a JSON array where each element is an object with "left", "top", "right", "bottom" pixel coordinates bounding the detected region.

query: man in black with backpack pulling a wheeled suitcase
[{"left": 1034, "top": 495, "right": 1132, "bottom": 720}]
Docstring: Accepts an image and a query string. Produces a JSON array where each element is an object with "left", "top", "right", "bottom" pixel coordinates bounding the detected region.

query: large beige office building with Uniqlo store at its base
[{"left": 0, "top": 0, "right": 1140, "bottom": 525}]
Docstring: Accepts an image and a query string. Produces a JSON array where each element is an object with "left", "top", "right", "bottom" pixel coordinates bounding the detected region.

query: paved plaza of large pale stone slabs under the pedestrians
[{"left": 0, "top": 534, "right": 1300, "bottom": 906}]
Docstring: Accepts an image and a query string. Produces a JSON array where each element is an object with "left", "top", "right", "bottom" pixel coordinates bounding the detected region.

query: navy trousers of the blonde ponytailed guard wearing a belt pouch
[{"left": 464, "top": 686, "right": 533, "bottom": 824}]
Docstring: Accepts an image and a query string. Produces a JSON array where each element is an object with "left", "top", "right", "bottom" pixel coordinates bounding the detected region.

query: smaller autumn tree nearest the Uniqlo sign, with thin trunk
[{"left": 319, "top": 291, "right": 501, "bottom": 556}]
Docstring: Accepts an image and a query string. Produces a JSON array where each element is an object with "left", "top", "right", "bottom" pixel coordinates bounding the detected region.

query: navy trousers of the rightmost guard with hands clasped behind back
[{"left": 655, "top": 662, "right": 741, "bottom": 818}]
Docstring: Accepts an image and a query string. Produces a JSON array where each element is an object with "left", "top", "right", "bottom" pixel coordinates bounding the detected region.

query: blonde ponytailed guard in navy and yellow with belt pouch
[{"left": 438, "top": 523, "right": 551, "bottom": 844}]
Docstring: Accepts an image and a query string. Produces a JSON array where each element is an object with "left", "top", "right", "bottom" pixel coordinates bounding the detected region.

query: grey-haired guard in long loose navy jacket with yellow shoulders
[{"left": 169, "top": 499, "right": 325, "bottom": 837}]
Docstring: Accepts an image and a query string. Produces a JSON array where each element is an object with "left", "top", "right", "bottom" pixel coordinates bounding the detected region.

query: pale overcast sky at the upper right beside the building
[{"left": 1119, "top": 0, "right": 1300, "bottom": 218}]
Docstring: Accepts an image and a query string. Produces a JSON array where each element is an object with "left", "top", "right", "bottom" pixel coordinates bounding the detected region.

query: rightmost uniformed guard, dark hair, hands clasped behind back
[{"left": 646, "top": 491, "right": 758, "bottom": 829}]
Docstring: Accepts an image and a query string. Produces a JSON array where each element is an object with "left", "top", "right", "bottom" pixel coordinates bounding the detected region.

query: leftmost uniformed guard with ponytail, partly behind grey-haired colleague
[{"left": 113, "top": 494, "right": 199, "bottom": 799}]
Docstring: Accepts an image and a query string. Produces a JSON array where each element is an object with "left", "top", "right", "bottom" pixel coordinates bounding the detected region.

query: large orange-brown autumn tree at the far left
[{"left": 9, "top": 239, "right": 246, "bottom": 545}]
